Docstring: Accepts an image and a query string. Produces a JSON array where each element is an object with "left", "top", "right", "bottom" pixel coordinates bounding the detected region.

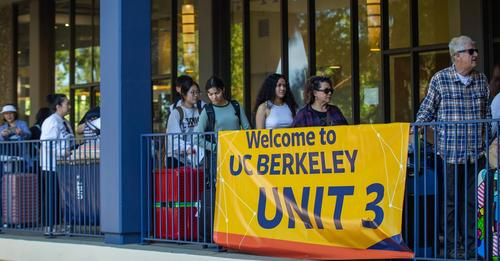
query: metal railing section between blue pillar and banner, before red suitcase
[{"left": 141, "top": 133, "right": 217, "bottom": 246}]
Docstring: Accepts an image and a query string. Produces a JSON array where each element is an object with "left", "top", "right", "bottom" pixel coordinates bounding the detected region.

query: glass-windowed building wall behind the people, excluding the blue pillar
[{"left": 0, "top": 0, "right": 500, "bottom": 128}]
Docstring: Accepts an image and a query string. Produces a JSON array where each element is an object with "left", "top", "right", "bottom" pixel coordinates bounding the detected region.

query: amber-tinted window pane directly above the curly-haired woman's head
[{"left": 250, "top": 0, "right": 281, "bottom": 111}]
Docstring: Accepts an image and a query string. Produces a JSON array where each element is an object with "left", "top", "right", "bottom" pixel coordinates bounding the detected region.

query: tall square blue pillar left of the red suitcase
[{"left": 100, "top": 0, "right": 152, "bottom": 244}]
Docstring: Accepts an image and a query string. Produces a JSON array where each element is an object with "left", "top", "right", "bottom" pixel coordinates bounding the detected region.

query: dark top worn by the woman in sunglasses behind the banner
[{"left": 292, "top": 104, "right": 348, "bottom": 127}]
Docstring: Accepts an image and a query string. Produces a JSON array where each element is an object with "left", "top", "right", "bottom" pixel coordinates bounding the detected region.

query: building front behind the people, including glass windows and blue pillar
[{"left": 0, "top": 0, "right": 500, "bottom": 243}]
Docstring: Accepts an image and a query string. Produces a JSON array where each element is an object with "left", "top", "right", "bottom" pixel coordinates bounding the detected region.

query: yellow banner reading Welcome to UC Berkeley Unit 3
[{"left": 214, "top": 123, "right": 412, "bottom": 258}]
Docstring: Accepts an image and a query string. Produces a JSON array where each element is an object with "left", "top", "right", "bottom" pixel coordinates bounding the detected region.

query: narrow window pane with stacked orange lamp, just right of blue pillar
[{"left": 177, "top": 0, "right": 200, "bottom": 81}]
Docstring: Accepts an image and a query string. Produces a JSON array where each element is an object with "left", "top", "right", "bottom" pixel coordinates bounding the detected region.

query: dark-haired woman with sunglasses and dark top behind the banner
[{"left": 292, "top": 76, "right": 348, "bottom": 127}]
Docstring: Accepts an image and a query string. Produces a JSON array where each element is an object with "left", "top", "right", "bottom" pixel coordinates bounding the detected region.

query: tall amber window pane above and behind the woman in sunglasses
[{"left": 316, "top": 0, "right": 352, "bottom": 122}]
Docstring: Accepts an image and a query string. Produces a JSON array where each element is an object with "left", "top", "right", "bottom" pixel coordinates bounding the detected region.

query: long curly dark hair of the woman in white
[{"left": 254, "top": 73, "right": 297, "bottom": 116}]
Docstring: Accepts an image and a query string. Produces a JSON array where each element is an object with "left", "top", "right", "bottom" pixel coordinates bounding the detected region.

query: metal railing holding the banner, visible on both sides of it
[{"left": 141, "top": 120, "right": 500, "bottom": 260}]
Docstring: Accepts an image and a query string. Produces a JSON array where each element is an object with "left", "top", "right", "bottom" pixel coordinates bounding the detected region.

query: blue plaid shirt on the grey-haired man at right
[{"left": 416, "top": 65, "right": 491, "bottom": 163}]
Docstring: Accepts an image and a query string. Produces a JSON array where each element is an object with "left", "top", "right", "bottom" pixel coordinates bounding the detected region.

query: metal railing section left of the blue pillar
[{"left": 0, "top": 138, "right": 101, "bottom": 236}]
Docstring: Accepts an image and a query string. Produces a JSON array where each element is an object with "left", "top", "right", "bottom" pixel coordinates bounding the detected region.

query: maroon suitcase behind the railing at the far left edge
[{"left": 2, "top": 173, "right": 39, "bottom": 225}]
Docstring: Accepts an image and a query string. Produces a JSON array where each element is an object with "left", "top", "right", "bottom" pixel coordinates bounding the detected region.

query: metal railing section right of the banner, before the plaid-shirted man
[{"left": 403, "top": 120, "right": 500, "bottom": 260}]
